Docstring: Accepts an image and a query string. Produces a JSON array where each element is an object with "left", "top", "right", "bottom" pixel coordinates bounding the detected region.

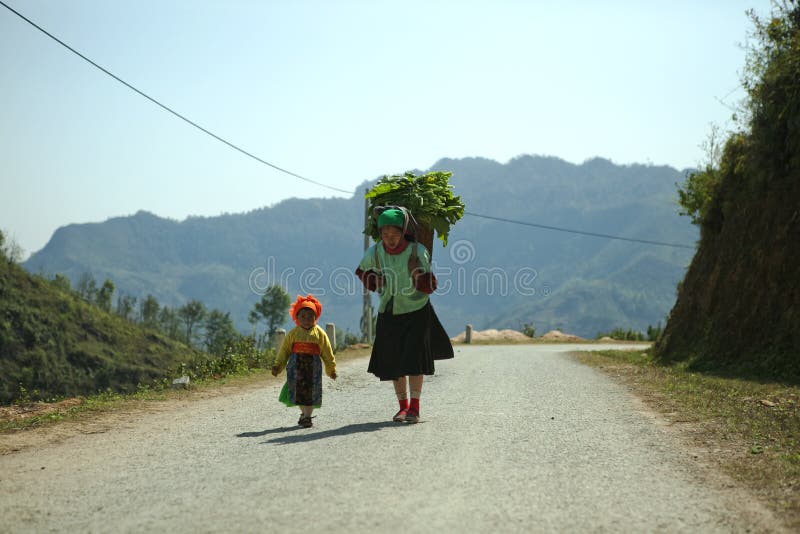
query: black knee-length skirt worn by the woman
[{"left": 367, "top": 301, "right": 453, "bottom": 380}]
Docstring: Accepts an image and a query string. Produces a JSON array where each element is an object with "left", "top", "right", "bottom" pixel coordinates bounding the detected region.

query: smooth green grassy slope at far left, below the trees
[{"left": 0, "top": 255, "right": 207, "bottom": 404}]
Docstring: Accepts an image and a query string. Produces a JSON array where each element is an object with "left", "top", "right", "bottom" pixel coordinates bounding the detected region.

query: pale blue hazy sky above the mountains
[{"left": 0, "top": 0, "right": 770, "bottom": 253}]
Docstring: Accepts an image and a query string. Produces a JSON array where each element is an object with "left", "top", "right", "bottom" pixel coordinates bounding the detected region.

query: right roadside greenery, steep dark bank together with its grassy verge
[{"left": 604, "top": 5, "right": 800, "bottom": 531}]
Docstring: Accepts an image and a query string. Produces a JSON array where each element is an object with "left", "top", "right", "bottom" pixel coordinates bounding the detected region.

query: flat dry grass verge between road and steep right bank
[{"left": 578, "top": 349, "right": 800, "bottom": 529}]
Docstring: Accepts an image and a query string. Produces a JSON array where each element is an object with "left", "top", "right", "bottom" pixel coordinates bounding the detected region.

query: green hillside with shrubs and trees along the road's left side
[{"left": 0, "top": 231, "right": 366, "bottom": 406}]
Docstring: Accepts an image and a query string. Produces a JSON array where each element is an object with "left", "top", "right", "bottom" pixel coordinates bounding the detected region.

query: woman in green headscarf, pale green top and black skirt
[{"left": 356, "top": 208, "right": 453, "bottom": 423}]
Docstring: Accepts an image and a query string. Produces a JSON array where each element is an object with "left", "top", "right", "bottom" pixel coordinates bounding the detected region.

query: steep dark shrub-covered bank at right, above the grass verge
[{"left": 656, "top": 3, "right": 800, "bottom": 382}]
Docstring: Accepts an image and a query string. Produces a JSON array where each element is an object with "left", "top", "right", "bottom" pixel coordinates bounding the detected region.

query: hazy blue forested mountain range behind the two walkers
[{"left": 24, "top": 156, "right": 697, "bottom": 336}]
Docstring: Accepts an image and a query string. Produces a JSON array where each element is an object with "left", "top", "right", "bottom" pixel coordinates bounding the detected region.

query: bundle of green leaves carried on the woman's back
[{"left": 364, "top": 171, "right": 464, "bottom": 248}]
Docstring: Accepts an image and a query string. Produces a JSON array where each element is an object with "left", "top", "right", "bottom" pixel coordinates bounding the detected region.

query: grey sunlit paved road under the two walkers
[{"left": 0, "top": 345, "right": 780, "bottom": 533}]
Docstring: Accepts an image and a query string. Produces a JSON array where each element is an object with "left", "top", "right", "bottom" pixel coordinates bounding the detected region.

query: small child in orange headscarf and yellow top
[{"left": 272, "top": 295, "right": 336, "bottom": 428}]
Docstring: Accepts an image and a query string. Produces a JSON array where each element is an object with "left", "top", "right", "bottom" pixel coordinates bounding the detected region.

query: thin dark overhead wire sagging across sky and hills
[{"left": 0, "top": 0, "right": 694, "bottom": 249}]
